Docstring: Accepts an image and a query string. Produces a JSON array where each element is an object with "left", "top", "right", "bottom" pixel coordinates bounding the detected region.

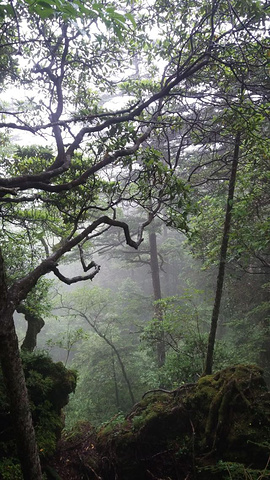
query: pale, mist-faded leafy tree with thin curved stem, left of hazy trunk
[{"left": 54, "top": 280, "right": 151, "bottom": 423}]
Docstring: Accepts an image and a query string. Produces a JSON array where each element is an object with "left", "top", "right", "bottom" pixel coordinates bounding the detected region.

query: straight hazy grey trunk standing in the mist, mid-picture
[{"left": 149, "top": 232, "right": 165, "bottom": 367}]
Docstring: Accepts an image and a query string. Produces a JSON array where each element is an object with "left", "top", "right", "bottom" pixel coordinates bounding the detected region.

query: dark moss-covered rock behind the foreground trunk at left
[{"left": 0, "top": 353, "right": 76, "bottom": 480}]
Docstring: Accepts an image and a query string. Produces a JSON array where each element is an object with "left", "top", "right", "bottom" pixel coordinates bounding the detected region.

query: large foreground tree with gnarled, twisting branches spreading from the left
[{"left": 0, "top": 0, "right": 267, "bottom": 480}]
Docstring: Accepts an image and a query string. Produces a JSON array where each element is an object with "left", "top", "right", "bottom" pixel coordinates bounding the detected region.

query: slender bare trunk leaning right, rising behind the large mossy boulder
[{"left": 204, "top": 132, "right": 240, "bottom": 375}]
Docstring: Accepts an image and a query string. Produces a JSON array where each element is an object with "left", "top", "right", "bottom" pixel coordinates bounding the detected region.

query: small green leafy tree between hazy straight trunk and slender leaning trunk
[{"left": 142, "top": 288, "right": 212, "bottom": 389}]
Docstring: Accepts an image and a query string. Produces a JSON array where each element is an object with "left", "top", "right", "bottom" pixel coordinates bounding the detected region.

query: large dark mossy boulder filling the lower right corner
[{"left": 96, "top": 365, "right": 270, "bottom": 480}]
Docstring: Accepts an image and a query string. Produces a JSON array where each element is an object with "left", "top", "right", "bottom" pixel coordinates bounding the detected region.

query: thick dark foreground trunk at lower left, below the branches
[{"left": 0, "top": 251, "right": 42, "bottom": 480}]
